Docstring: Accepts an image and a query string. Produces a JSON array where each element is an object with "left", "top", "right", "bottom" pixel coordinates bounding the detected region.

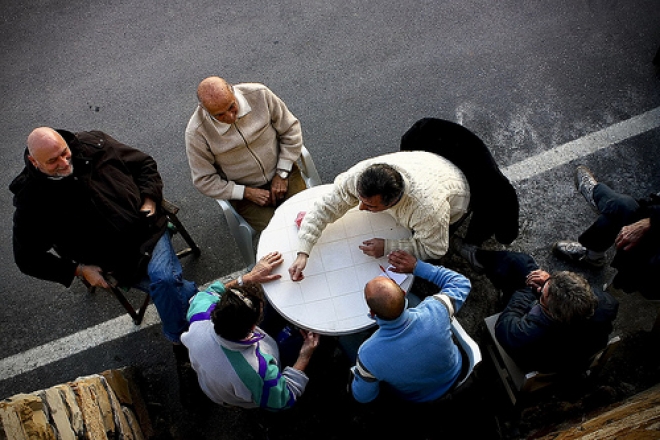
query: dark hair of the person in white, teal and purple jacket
[{"left": 211, "top": 283, "right": 264, "bottom": 341}]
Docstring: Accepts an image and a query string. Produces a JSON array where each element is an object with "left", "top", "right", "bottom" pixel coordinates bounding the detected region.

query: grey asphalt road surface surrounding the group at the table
[{"left": 0, "top": 0, "right": 660, "bottom": 439}]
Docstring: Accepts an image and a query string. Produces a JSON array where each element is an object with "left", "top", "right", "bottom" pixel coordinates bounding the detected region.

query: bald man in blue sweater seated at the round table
[{"left": 351, "top": 251, "right": 471, "bottom": 403}]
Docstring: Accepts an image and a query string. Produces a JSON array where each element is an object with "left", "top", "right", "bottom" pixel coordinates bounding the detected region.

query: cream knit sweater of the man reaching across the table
[{"left": 298, "top": 151, "right": 470, "bottom": 259}]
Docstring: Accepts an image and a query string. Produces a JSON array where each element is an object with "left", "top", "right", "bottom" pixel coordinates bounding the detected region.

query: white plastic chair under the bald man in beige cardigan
[{"left": 217, "top": 146, "right": 321, "bottom": 270}]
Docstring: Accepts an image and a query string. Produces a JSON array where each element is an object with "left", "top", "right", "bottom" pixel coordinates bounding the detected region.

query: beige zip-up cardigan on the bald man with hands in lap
[{"left": 186, "top": 83, "right": 303, "bottom": 200}]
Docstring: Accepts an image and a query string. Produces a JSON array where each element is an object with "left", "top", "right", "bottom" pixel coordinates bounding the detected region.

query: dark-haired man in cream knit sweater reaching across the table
[{"left": 289, "top": 151, "right": 470, "bottom": 281}]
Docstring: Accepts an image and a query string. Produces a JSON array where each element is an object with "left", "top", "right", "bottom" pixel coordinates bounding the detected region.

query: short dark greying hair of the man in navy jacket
[{"left": 547, "top": 271, "right": 598, "bottom": 325}]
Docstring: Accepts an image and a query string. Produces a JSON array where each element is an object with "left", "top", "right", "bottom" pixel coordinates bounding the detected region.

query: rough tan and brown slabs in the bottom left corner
[{"left": 0, "top": 370, "right": 153, "bottom": 440}]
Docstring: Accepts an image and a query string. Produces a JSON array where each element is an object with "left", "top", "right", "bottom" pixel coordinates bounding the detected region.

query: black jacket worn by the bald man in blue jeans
[{"left": 9, "top": 130, "right": 167, "bottom": 286}]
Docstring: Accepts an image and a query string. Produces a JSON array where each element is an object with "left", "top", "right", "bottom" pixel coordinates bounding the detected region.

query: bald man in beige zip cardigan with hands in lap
[{"left": 185, "top": 76, "right": 305, "bottom": 231}]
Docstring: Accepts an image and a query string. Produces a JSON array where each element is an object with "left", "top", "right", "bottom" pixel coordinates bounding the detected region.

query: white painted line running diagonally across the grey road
[{"left": 0, "top": 107, "right": 660, "bottom": 381}]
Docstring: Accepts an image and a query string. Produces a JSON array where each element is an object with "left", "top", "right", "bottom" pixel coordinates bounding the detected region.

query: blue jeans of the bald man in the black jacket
[{"left": 147, "top": 232, "right": 197, "bottom": 343}]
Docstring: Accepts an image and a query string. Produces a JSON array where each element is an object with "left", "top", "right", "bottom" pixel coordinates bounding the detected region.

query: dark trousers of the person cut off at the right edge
[{"left": 578, "top": 183, "right": 639, "bottom": 252}]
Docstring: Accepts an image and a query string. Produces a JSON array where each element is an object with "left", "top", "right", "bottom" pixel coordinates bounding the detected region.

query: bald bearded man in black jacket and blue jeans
[{"left": 9, "top": 127, "right": 197, "bottom": 343}]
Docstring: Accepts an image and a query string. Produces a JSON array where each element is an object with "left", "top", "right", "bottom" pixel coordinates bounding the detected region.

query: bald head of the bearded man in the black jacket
[{"left": 27, "top": 127, "right": 73, "bottom": 177}]
